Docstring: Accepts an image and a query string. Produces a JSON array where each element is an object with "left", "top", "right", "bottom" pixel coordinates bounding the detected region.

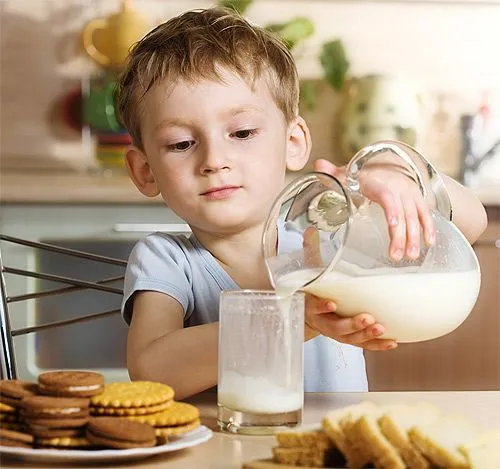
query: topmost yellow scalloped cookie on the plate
[{"left": 90, "top": 381, "right": 174, "bottom": 408}]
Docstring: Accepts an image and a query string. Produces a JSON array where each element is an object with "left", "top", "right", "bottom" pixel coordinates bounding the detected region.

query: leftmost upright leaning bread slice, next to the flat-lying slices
[{"left": 322, "top": 401, "right": 377, "bottom": 467}]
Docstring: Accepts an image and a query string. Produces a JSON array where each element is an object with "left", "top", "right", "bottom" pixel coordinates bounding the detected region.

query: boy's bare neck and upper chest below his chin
[{"left": 193, "top": 224, "right": 271, "bottom": 289}]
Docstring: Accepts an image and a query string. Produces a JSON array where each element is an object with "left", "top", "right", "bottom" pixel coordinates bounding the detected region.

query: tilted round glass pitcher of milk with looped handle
[{"left": 262, "top": 142, "right": 481, "bottom": 342}]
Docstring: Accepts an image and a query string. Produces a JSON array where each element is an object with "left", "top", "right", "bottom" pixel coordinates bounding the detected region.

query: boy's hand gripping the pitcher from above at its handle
[{"left": 314, "top": 159, "right": 436, "bottom": 261}]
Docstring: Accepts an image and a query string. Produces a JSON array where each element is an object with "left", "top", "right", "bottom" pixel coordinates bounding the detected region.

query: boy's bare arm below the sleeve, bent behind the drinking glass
[{"left": 127, "top": 291, "right": 219, "bottom": 400}]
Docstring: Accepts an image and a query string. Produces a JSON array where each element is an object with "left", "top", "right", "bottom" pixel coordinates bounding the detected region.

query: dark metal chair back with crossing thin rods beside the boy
[{"left": 0, "top": 235, "right": 127, "bottom": 379}]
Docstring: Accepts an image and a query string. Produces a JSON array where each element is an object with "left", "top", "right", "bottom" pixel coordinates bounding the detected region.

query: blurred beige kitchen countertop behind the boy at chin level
[{"left": 0, "top": 170, "right": 500, "bottom": 206}]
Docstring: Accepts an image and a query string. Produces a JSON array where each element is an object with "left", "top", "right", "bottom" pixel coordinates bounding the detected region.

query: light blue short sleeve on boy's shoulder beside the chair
[{"left": 122, "top": 233, "right": 194, "bottom": 324}]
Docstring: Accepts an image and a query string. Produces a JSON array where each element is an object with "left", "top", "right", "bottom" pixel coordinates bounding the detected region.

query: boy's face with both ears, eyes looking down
[{"left": 127, "top": 70, "right": 310, "bottom": 233}]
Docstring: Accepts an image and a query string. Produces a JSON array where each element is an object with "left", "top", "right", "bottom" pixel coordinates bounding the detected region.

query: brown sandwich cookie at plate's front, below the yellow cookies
[{"left": 86, "top": 417, "right": 156, "bottom": 449}]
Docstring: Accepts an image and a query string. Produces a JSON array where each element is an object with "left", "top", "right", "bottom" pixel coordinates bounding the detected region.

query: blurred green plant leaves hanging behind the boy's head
[{"left": 217, "top": 0, "right": 350, "bottom": 109}]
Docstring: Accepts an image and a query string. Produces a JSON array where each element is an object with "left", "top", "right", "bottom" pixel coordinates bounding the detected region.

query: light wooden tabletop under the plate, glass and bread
[{"left": 1, "top": 391, "right": 500, "bottom": 469}]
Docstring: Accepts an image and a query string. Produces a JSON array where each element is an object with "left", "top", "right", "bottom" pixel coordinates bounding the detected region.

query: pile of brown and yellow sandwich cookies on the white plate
[{"left": 0, "top": 371, "right": 200, "bottom": 449}]
